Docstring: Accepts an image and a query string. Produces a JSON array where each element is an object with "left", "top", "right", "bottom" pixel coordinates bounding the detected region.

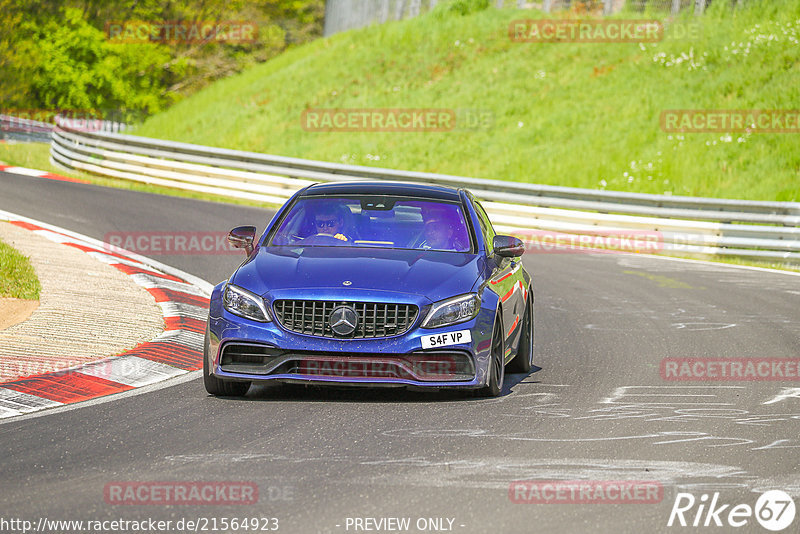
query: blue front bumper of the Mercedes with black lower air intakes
[{"left": 206, "top": 290, "right": 494, "bottom": 388}]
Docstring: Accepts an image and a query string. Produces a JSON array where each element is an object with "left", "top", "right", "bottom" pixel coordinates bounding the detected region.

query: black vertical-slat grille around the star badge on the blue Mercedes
[{"left": 273, "top": 300, "right": 419, "bottom": 339}]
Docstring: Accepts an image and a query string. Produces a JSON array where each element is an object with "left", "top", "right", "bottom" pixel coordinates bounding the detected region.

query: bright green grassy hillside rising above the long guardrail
[{"left": 135, "top": 0, "right": 800, "bottom": 201}]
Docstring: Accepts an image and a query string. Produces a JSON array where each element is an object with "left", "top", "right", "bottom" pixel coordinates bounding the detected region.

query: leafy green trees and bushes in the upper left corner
[{"left": 0, "top": 0, "right": 324, "bottom": 122}]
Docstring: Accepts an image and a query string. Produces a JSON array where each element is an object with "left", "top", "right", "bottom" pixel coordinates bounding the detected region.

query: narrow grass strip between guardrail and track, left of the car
[{"left": 0, "top": 143, "right": 277, "bottom": 208}]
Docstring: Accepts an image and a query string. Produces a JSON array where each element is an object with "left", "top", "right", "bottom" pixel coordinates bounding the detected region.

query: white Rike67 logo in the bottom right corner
[{"left": 667, "top": 490, "right": 795, "bottom": 532}]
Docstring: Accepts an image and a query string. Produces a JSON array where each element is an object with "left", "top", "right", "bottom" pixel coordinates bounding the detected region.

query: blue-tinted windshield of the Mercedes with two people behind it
[{"left": 269, "top": 196, "right": 472, "bottom": 252}]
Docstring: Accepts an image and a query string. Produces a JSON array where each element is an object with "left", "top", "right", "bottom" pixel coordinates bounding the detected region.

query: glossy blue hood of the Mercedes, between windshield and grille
[{"left": 232, "top": 247, "right": 483, "bottom": 302}]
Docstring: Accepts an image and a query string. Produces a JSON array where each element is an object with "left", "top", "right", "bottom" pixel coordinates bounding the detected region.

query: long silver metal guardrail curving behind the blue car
[{"left": 50, "top": 124, "right": 800, "bottom": 264}]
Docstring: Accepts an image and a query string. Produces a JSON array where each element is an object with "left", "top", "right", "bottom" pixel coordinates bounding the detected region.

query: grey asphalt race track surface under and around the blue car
[{"left": 0, "top": 169, "right": 800, "bottom": 533}]
